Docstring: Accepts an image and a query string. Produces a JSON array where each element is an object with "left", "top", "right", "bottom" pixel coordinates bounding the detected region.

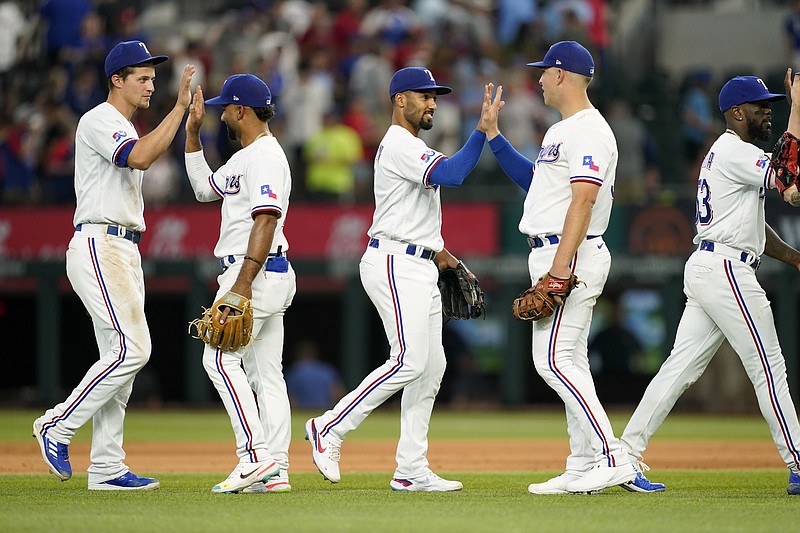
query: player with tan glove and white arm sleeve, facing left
[{"left": 185, "top": 74, "right": 295, "bottom": 493}]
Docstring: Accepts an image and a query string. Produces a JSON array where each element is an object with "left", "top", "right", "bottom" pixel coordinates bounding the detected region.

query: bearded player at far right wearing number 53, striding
[{"left": 621, "top": 70, "right": 800, "bottom": 495}]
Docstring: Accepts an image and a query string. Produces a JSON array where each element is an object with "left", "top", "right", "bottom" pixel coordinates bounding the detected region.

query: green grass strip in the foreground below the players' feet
[{"left": 0, "top": 471, "right": 800, "bottom": 533}]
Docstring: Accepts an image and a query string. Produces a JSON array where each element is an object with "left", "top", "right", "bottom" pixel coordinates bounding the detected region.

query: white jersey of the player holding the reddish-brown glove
[{"left": 519, "top": 109, "right": 617, "bottom": 236}]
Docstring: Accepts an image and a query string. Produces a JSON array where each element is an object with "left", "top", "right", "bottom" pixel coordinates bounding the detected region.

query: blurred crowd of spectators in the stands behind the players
[{"left": 0, "top": 0, "right": 620, "bottom": 205}]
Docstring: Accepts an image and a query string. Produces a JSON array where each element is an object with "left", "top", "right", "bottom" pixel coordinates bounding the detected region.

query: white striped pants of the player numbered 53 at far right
[{"left": 621, "top": 250, "right": 800, "bottom": 472}]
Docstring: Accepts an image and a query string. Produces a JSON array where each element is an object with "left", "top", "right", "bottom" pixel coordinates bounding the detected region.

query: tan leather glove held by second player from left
[{"left": 189, "top": 291, "right": 253, "bottom": 352}]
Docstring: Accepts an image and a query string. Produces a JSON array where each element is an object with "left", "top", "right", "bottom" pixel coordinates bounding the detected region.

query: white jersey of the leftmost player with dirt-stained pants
[{"left": 73, "top": 102, "right": 145, "bottom": 231}]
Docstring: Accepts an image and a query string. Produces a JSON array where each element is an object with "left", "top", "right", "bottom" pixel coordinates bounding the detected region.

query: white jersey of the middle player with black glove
[{"left": 367, "top": 125, "right": 445, "bottom": 251}]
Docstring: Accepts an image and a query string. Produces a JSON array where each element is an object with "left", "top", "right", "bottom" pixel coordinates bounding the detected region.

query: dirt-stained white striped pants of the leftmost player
[{"left": 41, "top": 232, "right": 151, "bottom": 484}]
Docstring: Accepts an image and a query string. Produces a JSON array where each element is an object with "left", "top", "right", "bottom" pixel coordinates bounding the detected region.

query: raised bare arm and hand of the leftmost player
[{"left": 125, "top": 65, "right": 195, "bottom": 170}]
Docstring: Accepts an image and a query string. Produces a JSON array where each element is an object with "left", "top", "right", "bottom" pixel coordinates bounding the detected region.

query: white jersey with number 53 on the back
[{"left": 694, "top": 131, "right": 775, "bottom": 255}]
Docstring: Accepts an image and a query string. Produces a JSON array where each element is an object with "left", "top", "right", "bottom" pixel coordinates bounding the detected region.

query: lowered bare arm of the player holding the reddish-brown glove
[{"left": 550, "top": 182, "right": 600, "bottom": 278}]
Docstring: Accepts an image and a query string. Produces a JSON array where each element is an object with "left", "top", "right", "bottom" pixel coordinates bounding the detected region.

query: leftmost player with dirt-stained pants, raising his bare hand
[{"left": 33, "top": 41, "right": 195, "bottom": 490}]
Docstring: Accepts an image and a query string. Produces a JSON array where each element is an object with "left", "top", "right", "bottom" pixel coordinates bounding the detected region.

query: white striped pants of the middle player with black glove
[{"left": 317, "top": 247, "right": 447, "bottom": 479}]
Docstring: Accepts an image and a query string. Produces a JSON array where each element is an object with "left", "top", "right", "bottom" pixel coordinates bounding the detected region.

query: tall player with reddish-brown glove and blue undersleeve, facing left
[{"left": 483, "top": 41, "right": 663, "bottom": 494}]
